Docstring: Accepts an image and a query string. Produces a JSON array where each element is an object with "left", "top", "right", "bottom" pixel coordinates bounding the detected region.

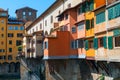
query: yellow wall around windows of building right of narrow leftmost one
[{"left": 7, "top": 24, "right": 24, "bottom": 62}]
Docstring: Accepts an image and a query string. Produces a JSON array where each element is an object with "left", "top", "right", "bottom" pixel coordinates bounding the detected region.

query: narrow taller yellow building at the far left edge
[{"left": 0, "top": 9, "right": 8, "bottom": 63}]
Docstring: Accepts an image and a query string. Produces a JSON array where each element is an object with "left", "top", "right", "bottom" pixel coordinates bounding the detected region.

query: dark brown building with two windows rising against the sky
[{"left": 15, "top": 7, "right": 37, "bottom": 21}]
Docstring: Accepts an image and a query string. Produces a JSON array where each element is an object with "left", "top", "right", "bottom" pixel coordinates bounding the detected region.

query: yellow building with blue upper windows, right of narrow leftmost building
[{"left": 7, "top": 18, "right": 24, "bottom": 62}]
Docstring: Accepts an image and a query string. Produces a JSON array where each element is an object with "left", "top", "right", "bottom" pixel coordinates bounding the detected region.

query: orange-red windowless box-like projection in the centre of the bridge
[{"left": 44, "top": 31, "right": 70, "bottom": 59}]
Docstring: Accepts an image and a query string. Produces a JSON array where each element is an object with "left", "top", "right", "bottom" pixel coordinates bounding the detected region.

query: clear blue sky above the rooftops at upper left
[{"left": 0, "top": 0, "right": 55, "bottom": 17}]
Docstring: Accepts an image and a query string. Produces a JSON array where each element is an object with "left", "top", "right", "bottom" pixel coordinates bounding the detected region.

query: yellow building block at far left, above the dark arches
[{"left": 0, "top": 9, "right": 24, "bottom": 63}]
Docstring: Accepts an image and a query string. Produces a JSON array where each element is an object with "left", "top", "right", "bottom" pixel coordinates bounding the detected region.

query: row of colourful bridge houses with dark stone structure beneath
[{"left": 24, "top": 0, "right": 120, "bottom": 80}]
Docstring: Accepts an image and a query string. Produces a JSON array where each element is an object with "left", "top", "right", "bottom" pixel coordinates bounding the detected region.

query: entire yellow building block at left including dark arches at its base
[{"left": 0, "top": 9, "right": 24, "bottom": 79}]
